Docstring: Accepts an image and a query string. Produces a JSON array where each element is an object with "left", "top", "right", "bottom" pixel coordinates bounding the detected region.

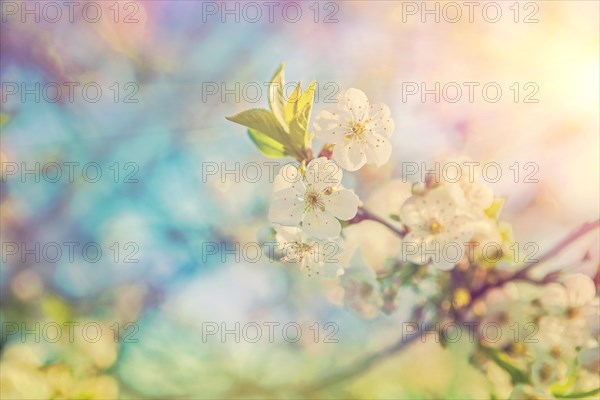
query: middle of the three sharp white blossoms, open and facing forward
[{"left": 269, "top": 157, "right": 359, "bottom": 239}]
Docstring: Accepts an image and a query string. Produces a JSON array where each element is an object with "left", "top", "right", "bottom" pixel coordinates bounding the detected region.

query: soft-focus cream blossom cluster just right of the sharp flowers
[{"left": 400, "top": 161, "right": 503, "bottom": 270}]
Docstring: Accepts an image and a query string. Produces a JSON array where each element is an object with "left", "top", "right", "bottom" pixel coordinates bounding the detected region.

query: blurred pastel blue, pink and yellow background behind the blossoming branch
[{"left": 0, "top": 1, "right": 600, "bottom": 399}]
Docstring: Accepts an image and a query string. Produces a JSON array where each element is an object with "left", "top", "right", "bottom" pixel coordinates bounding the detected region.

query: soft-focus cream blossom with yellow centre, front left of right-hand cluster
[{"left": 400, "top": 186, "right": 472, "bottom": 270}]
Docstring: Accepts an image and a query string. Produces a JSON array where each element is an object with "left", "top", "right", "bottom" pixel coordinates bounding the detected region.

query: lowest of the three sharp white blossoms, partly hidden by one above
[{"left": 275, "top": 226, "right": 344, "bottom": 277}]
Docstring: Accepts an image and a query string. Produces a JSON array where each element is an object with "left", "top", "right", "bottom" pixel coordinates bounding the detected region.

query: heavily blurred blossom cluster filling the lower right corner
[{"left": 476, "top": 274, "right": 600, "bottom": 399}]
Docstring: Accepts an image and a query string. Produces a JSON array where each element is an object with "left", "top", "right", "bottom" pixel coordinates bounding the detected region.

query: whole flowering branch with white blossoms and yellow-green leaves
[{"left": 233, "top": 65, "right": 600, "bottom": 399}]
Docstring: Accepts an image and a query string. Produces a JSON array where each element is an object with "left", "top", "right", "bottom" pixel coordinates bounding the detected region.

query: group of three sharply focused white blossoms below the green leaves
[{"left": 269, "top": 89, "right": 394, "bottom": 275}]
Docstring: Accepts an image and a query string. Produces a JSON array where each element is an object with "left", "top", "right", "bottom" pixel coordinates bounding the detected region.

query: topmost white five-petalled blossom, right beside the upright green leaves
[{"left": 315, "top": 89, "right": 394, "bottom": 171}]
